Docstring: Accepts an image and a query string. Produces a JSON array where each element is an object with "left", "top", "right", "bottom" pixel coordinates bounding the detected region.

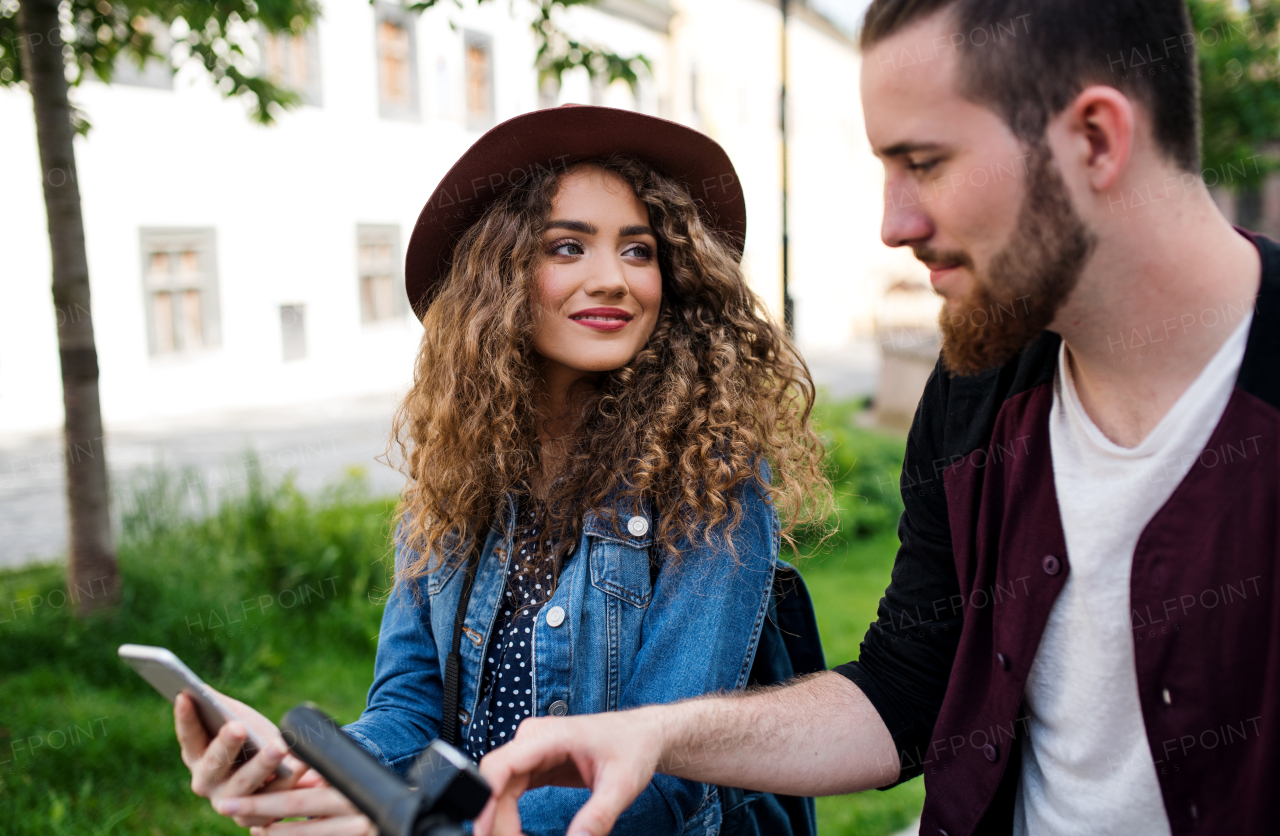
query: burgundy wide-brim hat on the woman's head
[{"left": 404, "top": 105, "right": 746, "bottom": 319}]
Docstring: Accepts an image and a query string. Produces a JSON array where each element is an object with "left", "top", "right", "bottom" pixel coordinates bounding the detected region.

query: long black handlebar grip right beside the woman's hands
[{"left": 280, "top": 703, "right": 422, "bottom": 836}]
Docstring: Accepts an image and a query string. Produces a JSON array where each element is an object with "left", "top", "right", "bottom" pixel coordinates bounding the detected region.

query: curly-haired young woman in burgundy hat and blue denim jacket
[{"left": 175, "top": 106, "right": 827, "bottom": 836}]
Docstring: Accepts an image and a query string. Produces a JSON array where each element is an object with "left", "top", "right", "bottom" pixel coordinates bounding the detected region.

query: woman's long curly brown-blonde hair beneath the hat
[{"left": 389, "top": 156, "right": 831, "bottom": 581}]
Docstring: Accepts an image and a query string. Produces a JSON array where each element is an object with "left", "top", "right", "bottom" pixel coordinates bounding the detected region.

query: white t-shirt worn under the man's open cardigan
[{"left": 1014, "top": 318, "right": 1249, "bottom": 836}]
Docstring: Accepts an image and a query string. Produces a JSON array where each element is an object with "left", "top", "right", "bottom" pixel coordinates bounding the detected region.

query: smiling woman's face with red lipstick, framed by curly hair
[{"left": 534, "top": 165, "right": 662, "bottom": 383}]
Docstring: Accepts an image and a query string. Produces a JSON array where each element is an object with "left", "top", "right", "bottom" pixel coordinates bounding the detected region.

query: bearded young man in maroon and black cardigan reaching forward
[{"left": 476, "top": 0, "right": 1280, "bottom": 836}]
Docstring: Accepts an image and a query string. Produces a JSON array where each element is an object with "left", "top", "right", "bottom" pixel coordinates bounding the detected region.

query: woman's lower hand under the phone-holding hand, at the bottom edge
[{"left": 214, "top": 773, "right": 378, "bottom": 836}]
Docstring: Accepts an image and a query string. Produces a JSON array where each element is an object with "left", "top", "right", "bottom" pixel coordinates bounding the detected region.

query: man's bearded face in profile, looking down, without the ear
[{"left": 861, "top": 13, "right": 1092, "bottom": 374}]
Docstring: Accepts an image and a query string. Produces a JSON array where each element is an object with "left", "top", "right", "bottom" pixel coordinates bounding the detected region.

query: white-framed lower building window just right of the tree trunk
[{"left": 142, "top": 229, "right": 221, "bottom": 355}]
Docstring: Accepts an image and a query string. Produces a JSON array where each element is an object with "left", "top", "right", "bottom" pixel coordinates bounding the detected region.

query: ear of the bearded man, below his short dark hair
[{"left": 1055, "top": 84, "right": 1137, "bottom": 193}]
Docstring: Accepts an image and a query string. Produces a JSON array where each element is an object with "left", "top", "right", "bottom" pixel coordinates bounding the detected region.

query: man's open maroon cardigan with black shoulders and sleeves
[{"left": 836, "top": 230, "right": 1280, "bottom": 836}]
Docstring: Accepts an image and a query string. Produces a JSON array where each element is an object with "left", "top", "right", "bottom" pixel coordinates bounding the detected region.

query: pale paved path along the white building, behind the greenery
[{"left": 0, "top": 343, "right": 879, "bottom": 568}]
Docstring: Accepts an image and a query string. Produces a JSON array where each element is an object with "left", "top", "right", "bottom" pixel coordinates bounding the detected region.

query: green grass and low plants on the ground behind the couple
[{"left": 0, "top": 408, "right": 923, "bottom": 836}]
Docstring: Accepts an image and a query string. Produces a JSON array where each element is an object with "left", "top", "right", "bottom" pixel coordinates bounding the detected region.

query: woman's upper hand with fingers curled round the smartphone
[{"left": 173, "top": 691, "right": 319, "bottom": 827}]
